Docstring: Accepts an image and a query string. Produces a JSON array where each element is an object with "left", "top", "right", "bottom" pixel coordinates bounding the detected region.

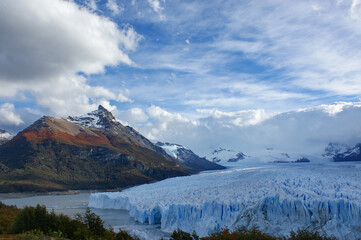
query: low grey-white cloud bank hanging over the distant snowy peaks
[{"left": 118, "top": 102, "right": 361, "bottom": 155}]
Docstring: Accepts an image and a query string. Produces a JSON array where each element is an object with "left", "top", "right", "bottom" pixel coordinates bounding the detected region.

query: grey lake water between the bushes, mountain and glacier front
[{"left": 0, "top": 193, "right": 169, "bottom": 239}]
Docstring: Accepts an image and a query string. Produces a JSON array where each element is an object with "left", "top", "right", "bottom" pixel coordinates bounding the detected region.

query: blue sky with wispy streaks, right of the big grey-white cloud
[{"left": 89, "top": 1, "right": 361, "bottom": 113}]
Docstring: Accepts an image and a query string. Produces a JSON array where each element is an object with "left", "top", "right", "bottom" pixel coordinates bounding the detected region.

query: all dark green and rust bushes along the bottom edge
[{"left": 0, "top": 202, "right": 335, "bottom": 240}]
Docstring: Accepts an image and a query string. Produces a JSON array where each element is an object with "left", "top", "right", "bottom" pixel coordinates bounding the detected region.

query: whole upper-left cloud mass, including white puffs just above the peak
[{"left": 0, "top": 0, "right": 142, "bottom": 116}]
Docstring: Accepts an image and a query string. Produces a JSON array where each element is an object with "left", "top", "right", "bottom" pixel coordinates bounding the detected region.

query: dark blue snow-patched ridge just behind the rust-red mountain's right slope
[{"left": 157, "top": 142, "right": 224, "bottom": 171}]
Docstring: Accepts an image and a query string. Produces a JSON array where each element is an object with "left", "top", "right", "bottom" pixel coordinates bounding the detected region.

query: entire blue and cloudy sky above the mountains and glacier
[{"left": 0, "top": 0, "right": 361, "bottom": 156}]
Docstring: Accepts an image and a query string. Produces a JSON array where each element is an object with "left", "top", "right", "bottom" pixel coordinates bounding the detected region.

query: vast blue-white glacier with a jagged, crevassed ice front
[{"left": 89, "top": 162, "right": 361, "bottom": 239}]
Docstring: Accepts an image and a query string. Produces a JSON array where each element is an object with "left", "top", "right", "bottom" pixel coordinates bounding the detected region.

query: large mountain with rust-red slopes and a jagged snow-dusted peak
[{"left": 0, "top": 106, "right": 220, "bottom": 192}]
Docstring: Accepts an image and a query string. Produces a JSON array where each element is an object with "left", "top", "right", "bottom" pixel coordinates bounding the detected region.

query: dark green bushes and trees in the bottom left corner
[{"left": 0, "top": 202, "right": 138, "bottom": 240}]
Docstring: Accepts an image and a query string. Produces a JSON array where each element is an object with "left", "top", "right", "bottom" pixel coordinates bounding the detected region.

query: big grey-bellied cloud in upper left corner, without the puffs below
[{"left": 0, "top": 0, "right": 133, "bottom": 81}]
